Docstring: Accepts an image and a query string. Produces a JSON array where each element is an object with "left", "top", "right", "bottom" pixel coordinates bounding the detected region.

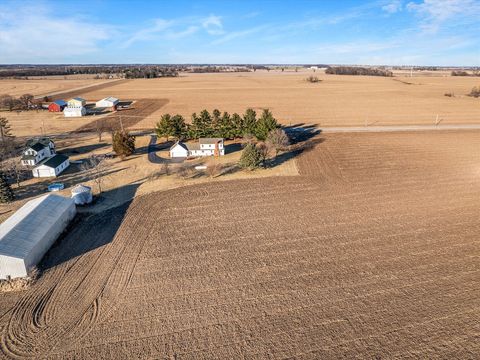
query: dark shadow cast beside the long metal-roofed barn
[{"left": 38, "top": 183, "right": 140, "bottom": 273}]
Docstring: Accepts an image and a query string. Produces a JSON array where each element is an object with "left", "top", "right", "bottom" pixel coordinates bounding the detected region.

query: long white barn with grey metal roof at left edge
[{"left": 0, "top": 194, "right": 76, "bottom": 279}]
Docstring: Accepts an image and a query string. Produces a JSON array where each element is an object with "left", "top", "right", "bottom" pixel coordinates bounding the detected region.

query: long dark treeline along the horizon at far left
[{"left": 0, "top": 65, "right": 184, "bottom": 79}]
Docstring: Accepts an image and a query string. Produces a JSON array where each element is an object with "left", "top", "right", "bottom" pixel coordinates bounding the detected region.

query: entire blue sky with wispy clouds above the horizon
[{"left": 0, "top": 0, "right": 480, "bottom": 66}]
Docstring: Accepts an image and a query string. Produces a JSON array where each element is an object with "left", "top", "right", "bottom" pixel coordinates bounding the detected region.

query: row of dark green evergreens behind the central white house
[{"left": 155, "top": 109, "right": 278, "bottom": 141}]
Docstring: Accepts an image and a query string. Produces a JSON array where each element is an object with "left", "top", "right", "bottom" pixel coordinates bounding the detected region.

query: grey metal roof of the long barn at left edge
[{"left": 0, "top": 194, "right": 73, "bottom": 259}]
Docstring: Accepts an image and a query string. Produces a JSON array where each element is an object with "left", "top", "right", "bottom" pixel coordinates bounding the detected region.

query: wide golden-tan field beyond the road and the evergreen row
[{"left": 80, "top": 70, "right": 480, "bottom": 128}]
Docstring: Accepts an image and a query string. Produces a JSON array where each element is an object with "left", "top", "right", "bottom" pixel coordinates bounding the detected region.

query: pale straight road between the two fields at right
[{"left": 318, "top": 124, "right": 480, "bottom": 133}]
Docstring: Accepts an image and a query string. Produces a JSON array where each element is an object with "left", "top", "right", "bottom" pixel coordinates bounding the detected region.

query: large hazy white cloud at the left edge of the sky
[{"left": 0, "top": 4, "right": 115, "bottom": 63}]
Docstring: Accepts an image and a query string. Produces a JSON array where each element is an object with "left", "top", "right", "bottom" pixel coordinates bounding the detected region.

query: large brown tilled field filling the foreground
[{"left": 0, "top": 131, "right": 480, "bottom": 359}]
